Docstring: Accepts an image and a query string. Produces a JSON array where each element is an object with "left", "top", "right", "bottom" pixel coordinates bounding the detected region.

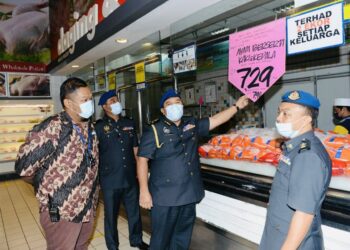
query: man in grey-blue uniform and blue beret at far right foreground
[{"left": 260, "top": 91, "right": 332, "bottom": 250}]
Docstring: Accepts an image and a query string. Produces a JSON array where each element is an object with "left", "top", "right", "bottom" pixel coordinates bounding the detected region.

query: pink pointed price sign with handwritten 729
[{"left": 228, "top": 18, "right": 286, "bottom": 102}]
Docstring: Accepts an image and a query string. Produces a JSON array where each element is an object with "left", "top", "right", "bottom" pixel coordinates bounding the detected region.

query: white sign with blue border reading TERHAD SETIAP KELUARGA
[{"left": 287, "top": 2, "right": 344, "bottom": 55}]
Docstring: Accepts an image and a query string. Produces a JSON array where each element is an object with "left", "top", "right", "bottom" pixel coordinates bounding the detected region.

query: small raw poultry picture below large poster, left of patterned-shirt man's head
[{"left": 8, "top": 73, "right": 50, "bottom": 97}]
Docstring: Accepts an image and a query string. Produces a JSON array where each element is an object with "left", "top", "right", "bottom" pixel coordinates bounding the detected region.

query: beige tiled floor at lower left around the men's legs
[{"left": 0, "top": 180, "right": 149, "bottom": 250}]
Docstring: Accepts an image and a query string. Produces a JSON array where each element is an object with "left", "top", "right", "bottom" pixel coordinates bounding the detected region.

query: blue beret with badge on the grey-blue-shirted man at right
[{"left": 282, "top": 90, "right": 321, "bottom": 109}]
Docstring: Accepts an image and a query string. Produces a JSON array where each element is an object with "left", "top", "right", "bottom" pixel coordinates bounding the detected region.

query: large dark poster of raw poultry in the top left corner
[{"left": 0, "top": 0, "right": 51, "bottom": 73}]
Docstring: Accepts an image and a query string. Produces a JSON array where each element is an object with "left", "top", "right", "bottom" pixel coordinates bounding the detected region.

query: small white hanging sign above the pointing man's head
[{"left": 173, "top": 44, "right": 197, "bottom": 74}]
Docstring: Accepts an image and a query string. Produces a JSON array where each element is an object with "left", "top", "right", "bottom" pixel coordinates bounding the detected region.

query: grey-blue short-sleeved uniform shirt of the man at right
[{"left": 260, "top": 131, "right": 332, "bottom": 250}]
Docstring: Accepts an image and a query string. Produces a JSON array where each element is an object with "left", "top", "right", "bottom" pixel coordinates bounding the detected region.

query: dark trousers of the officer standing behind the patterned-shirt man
[{"left": 102, "top": 185, "right": 142, "bottom": 250}]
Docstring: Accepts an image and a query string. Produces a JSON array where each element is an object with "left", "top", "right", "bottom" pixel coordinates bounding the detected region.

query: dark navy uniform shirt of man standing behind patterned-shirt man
[{"left": 96, "top": 116, "right": 138, "bottom": 189}]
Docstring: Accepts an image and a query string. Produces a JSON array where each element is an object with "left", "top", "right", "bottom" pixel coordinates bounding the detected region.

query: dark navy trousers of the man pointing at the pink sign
[{"left": 150, "top": 203, "right": 196, "bottom": 250}]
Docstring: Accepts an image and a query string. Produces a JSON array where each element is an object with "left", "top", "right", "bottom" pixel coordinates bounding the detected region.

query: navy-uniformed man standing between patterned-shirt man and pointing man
[{"left": 96, "top": 90, "right": 148, "bottom": 250}]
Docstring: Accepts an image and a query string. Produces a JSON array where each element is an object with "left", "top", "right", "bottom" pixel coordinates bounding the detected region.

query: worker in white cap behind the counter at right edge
[{"left": 334, "top": 98, "right": 350, "bottom": 135}]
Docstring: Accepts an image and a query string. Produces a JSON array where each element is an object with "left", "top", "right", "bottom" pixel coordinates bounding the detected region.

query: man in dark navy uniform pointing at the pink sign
[{"left": 137, "top": 90, "right": 248, "bottom": 250}]
